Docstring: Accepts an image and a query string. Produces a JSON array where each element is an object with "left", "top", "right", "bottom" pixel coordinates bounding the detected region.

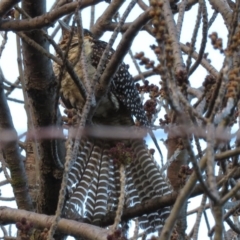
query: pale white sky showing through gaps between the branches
[{"left": 0, "top": 0, "right": 227, "bottom": 239}]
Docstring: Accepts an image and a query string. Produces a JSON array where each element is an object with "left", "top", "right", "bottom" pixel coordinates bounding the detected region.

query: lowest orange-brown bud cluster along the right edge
[{"left": 226, "top": 68, "right": 240, "bottom": 100}]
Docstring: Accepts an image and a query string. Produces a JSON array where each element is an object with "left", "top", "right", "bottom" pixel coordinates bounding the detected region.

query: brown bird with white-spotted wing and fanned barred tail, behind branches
[{"left": 53, "top": 21, "right": 171, "bottom": 233}]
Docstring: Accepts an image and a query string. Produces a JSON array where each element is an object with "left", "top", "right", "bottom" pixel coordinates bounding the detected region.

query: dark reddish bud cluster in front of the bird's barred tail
[{"left": 109, "top": 142, "right": 135, "bottom": 165}]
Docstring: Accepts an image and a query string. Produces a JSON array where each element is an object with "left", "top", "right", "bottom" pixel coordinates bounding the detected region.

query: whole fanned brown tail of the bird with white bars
[{"left": 64, "top": 139, "right": 170, "bottom": 232}]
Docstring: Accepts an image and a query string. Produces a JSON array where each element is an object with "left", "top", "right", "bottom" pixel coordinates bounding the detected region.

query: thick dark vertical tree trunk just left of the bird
[{"left": 22, "top": 0, "right": 61, "bottom": 214}]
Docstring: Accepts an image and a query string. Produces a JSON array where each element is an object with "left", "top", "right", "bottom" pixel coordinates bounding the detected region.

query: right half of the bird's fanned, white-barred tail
[{"left": 130, "top": 140, "right": 170, "bottom": 232}]
